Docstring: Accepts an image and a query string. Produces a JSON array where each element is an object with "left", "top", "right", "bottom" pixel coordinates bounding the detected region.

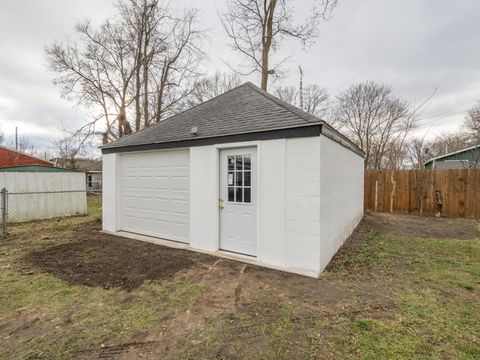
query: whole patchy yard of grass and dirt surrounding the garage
[{"left": 0, "top": 197, "right": 480, "bottom": 359}]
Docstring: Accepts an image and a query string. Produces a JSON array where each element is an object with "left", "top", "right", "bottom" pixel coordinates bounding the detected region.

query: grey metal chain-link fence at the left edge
[{"left": 0, "top": 188, "right": 87, "bottom": 237}]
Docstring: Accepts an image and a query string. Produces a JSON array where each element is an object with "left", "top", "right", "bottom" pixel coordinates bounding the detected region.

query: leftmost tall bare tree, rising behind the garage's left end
[{"left": 46, "top": 21, "right": 135, "bottom": 139}]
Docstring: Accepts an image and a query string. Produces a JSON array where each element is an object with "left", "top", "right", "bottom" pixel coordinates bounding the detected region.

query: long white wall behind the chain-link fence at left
[{"left": 0, "top": 172, "right": 87, "bottom": 221}]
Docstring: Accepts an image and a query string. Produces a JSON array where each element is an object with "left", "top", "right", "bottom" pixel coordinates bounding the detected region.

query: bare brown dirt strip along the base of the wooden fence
[{"left": 364, "top": 213, "right": 480, "bottom": 240}]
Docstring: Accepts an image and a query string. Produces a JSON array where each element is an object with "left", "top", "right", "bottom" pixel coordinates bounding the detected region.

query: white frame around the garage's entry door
[{"left": 214, "top": 141, "right": 262, "bottom": 259}]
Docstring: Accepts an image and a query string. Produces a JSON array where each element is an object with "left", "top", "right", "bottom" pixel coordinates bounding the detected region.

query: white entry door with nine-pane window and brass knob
[{"left": 219, "top": 147, "right": 257, "bottom": 256}]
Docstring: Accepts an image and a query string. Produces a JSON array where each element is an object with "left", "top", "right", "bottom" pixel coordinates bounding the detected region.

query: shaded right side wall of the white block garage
[{"left": 320, "top": 136, "right": 364, "bottom": 271}]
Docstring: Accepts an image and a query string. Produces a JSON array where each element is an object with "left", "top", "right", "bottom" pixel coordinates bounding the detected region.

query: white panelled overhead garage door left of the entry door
[{"left": 119, "top": 150, "right": 189, "bottom": 242}]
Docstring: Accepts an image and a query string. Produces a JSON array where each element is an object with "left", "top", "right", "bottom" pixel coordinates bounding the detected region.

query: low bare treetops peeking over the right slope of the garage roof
[{"left": 273, "top": 84, "right": 330, "bottom": 117}]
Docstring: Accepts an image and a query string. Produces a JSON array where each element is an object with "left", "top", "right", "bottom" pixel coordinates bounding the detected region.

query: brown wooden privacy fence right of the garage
[{"left": 365, "top": 169, "right": 480, "bottom": 219}]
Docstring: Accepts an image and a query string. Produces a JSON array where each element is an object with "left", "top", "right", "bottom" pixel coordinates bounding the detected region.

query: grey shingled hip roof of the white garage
[{"left": 102, "top": 82, "right": 364, "bottom": 156}]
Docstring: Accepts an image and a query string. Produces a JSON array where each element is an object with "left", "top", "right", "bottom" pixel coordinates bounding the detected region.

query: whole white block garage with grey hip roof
[{"left": 102, "top": 83, "right": 364, "bottom": 277}]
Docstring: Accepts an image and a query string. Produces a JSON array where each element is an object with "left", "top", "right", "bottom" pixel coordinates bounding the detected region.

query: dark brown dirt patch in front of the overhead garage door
[{"left": 24, "top": 229, "right": 215, "bottom": 290}]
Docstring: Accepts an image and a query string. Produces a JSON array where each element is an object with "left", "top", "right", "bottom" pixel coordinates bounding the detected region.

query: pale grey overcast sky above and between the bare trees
[{"left": 0, "top": 0, "right": 480, "bottom": 153}]
